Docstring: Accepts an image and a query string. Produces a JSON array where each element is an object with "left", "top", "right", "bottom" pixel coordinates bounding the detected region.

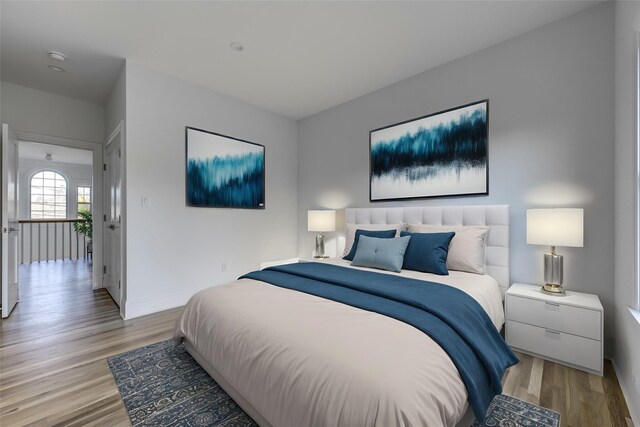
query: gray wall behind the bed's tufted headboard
[{"left": 298, "top": 4, "right": 614, "bottom": 350}]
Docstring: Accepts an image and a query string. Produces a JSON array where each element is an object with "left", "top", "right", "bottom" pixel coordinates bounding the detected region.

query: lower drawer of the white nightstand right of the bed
[{"left": 506, "top": 320, "right": 602, "bottom": 372}]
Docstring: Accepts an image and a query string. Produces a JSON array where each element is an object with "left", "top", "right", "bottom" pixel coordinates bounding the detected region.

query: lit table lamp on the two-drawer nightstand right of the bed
[{"left": 527, "top": 208, "right": 584, "bottom": 296}]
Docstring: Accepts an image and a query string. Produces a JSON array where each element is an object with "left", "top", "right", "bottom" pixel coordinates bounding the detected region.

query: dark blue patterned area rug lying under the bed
[{"left": 107, "top": 340, "right": 560, "bottom": 427}]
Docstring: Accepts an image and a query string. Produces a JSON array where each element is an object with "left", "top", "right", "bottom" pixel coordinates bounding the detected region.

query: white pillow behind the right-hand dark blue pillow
[{"left": 407, "top": 224, "right": 489, "bottom": 274}]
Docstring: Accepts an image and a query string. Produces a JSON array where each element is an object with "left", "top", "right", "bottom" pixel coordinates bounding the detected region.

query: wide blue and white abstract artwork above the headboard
[{"left": 369, "top": 100, "right": 489, "bottom": 201}]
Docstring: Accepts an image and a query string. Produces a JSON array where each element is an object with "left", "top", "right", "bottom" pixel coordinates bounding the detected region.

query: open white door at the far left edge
[{"left": 0, "top": 123, "right": 18, "bottom": 318}]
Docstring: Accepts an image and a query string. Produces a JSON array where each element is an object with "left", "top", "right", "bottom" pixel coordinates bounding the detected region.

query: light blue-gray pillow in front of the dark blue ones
[{"left": 351, "top": 236, "right": 411, "bottom": 272}]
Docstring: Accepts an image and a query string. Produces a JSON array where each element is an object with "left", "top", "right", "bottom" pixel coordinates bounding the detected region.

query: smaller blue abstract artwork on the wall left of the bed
[{"left": 186, "top": 127, "right": 265, "bottom": 209}]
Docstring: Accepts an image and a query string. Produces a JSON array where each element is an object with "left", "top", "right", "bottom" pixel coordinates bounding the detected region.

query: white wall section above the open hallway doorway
[{"left": 0, "top": 82, "right": 105, "bottom": 143}]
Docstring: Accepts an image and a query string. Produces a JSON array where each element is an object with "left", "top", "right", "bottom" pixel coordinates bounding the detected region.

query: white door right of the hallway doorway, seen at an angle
[{"left": 103, "top": 131, "right": 122, "bottom": 306}]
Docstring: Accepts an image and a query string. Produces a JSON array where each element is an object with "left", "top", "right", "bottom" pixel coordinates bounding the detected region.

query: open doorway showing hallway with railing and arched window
[{"left": 18, "top": 140, "right": 94, "bottom": 306}]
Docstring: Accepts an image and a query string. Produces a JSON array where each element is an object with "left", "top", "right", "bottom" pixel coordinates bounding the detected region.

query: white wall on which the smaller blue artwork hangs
[{"left": 125, "top": 62, "right": 298, "bottom": 317}]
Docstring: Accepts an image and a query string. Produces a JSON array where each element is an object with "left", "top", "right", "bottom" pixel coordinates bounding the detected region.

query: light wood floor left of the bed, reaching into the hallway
[{"left": 0, "top": 260, "right": 180, "bottom": 426}]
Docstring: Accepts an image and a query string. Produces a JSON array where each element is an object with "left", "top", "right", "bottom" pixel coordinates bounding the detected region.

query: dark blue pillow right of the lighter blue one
[{"left": 400, "top": 231, "right": 456, "bottom": 276}]
